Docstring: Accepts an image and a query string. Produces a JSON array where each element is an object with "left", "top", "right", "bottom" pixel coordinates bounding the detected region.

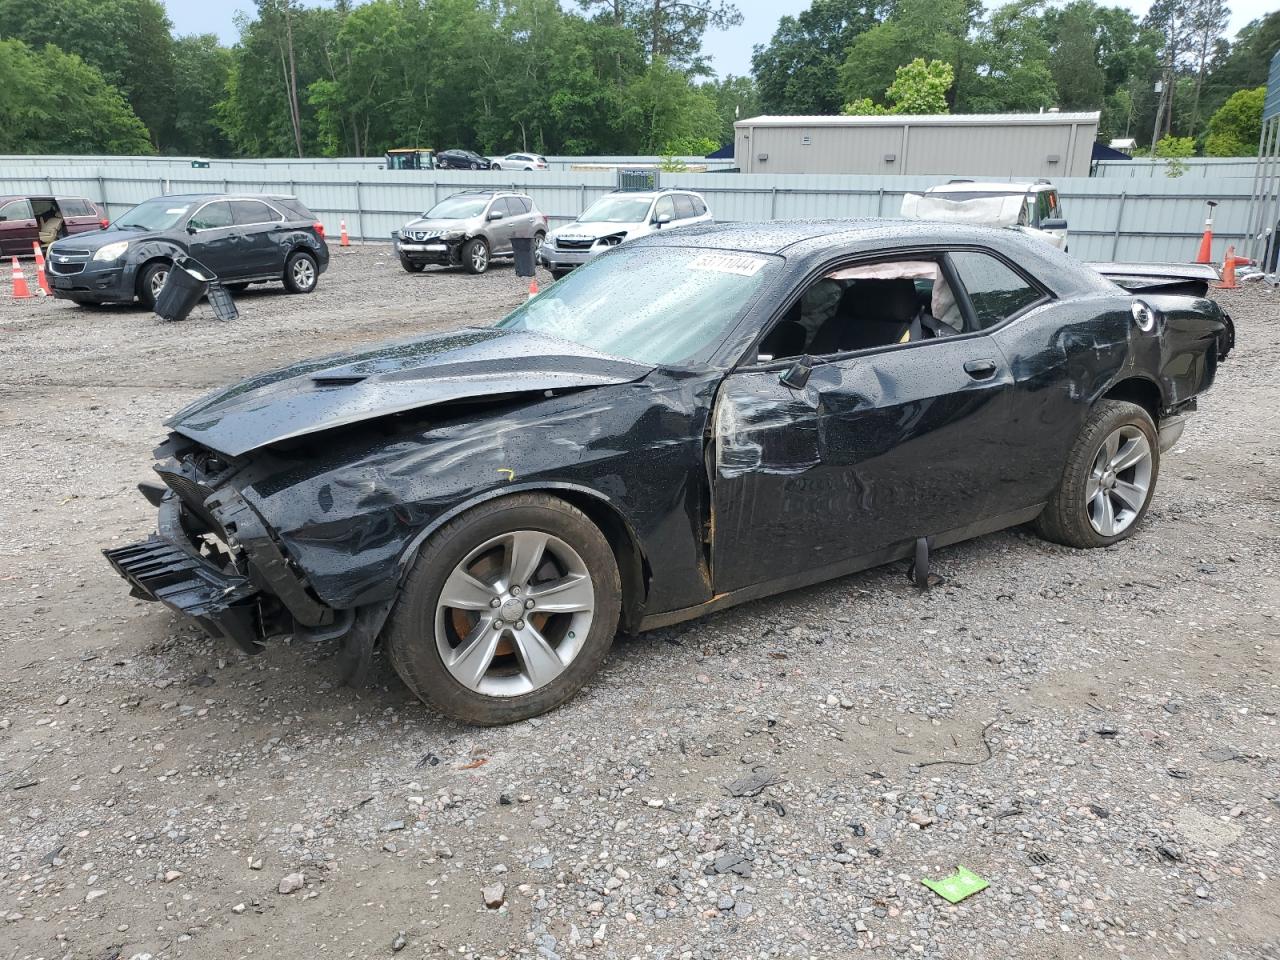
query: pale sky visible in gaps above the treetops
[{"left": 165, "top": 0, "right": 1276, "bottom": 77}]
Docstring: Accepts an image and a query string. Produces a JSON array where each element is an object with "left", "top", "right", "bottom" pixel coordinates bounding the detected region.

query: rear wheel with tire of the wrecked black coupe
[{"left": 1034, "top": 401, "right": 1160, "bottom": 549}]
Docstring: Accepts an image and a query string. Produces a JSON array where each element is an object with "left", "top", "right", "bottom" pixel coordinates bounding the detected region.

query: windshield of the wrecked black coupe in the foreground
[{"left": 498, "top": 247, "right": 782, "bottom": 365}]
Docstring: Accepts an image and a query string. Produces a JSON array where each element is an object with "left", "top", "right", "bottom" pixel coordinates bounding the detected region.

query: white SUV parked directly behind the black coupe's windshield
[{"left": 538, "top": 189, "right": 712, "bottom": 279}]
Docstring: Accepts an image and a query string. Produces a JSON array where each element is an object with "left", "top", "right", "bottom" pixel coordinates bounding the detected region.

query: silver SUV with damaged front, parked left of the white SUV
[{"left": 394, "top": 189, "right": 547, "bottom": 274}]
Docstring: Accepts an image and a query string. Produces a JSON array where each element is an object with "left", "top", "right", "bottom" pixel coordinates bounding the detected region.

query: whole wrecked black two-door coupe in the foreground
[{"left": 106, "top": 220, "right": 1230, "bottom": 723}]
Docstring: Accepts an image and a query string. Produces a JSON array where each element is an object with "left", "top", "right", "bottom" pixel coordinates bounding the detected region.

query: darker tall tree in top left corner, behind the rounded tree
[{"left": 0, "top": 0, "right": 174, "bottom": 146}]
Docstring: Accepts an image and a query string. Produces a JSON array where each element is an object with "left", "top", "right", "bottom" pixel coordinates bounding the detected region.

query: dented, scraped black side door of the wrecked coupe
[{"left": 710, "top": 253, "right": 1012, "bottom": 593}]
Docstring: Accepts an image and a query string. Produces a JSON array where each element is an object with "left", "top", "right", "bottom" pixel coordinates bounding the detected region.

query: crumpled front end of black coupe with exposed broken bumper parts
[{"left": 102, "top": 436, "right": 352, "bottom": 653}]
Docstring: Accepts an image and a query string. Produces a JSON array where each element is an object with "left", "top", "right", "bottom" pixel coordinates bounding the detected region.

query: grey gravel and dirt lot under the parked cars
[{"left": 0, "top": 247, "right": 1280, "bottom": 960}]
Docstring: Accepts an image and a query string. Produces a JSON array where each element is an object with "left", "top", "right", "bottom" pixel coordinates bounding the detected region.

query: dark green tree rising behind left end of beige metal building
[{"left": 751, "top": 0, "right": 887, "bottom": 114}]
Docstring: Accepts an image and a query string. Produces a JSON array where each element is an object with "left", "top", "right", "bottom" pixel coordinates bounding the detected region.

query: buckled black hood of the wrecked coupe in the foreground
[{"left": 165, "top": 328, "right": 653, "bottom": 457}]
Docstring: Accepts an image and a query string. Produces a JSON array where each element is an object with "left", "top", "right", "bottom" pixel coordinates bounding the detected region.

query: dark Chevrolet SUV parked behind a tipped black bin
[{"left": 49, "top": 193, "right": 329, "bottom": 308}]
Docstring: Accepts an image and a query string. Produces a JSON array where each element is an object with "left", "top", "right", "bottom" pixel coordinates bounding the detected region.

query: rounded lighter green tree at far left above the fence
[{"left": 0, "top": 40, "right": 154, "bottom": 155}]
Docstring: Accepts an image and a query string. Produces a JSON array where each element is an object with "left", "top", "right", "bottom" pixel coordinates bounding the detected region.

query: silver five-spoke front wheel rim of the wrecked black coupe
[{"left": 435, "top": 530, "right": 595, "bottom": 696}]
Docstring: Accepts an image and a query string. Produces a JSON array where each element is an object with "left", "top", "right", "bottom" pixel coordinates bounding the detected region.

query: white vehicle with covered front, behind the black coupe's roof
[{"left": 902, "top": 180, "right": 1068, "bottom": 251}]
